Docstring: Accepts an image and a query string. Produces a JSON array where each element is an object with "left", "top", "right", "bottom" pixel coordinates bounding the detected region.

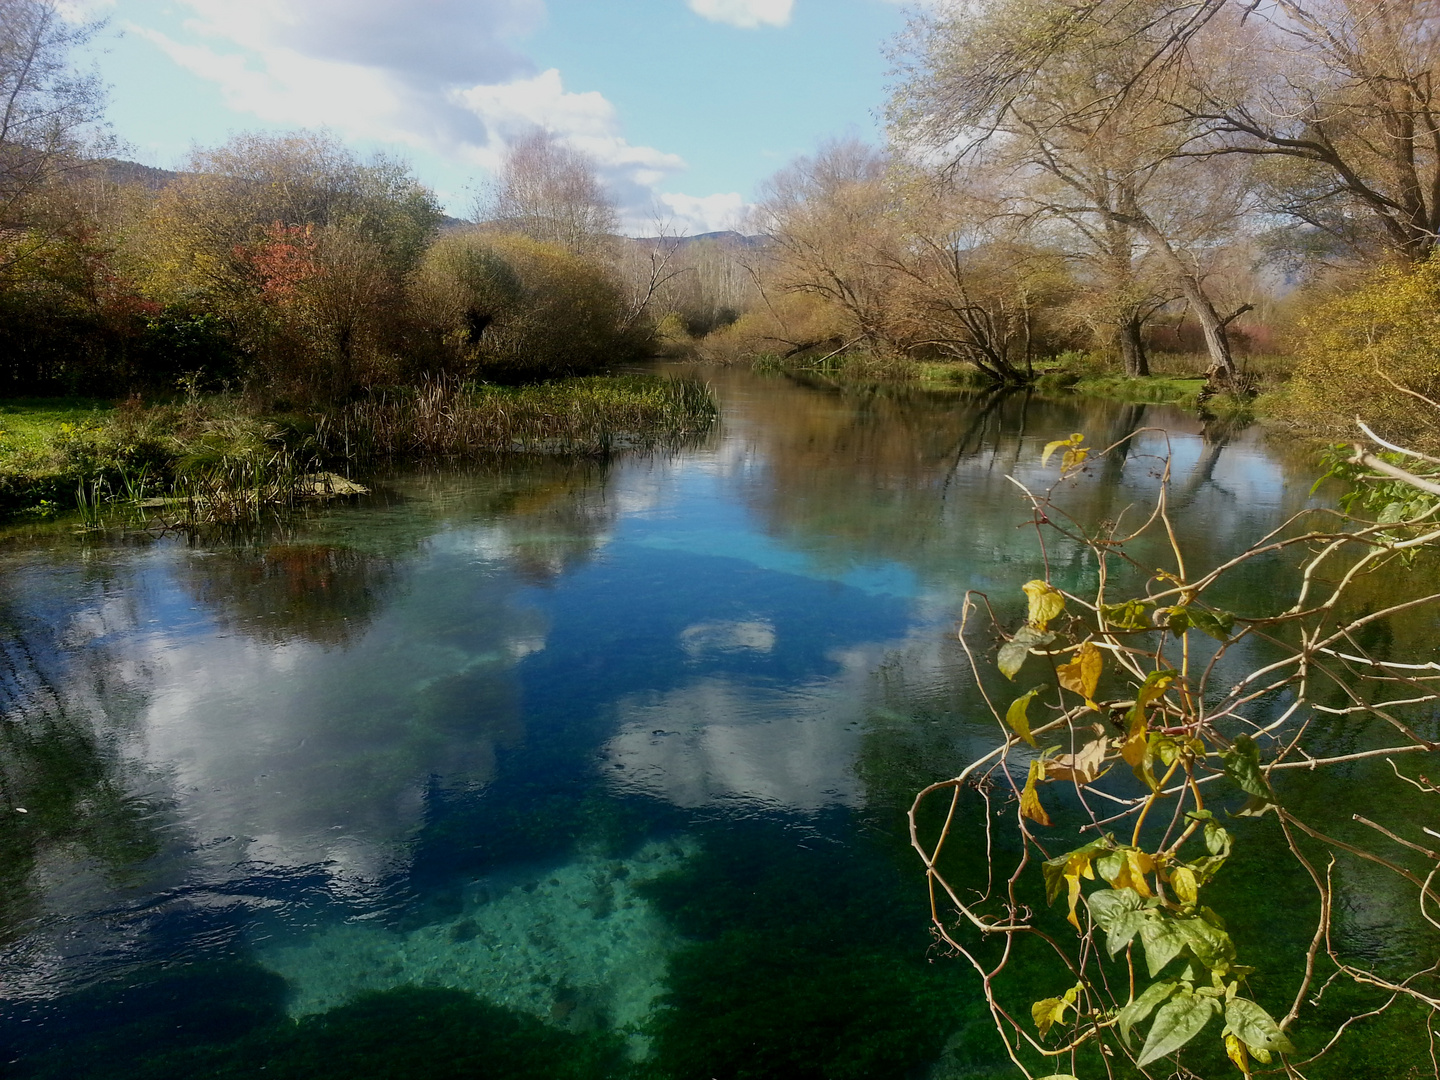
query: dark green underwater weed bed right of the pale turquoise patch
[{"left": 642, "top": 811, "right": 989, "bottom": 1080}]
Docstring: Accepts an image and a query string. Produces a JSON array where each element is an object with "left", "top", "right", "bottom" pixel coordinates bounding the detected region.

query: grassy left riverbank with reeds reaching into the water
[{"left": 0, "top": 376, "right": 716, "bottom": 517}]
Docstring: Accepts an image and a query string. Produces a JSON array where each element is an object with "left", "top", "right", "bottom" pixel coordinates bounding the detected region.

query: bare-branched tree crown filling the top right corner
[{"left": 1186, "top": 0, "right": 1440, "bottom": 262}]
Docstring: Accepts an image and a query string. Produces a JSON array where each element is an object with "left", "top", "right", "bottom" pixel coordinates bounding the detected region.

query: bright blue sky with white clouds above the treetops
[{"left": 75, "top": 0, "right": 906, "bottom": 232}]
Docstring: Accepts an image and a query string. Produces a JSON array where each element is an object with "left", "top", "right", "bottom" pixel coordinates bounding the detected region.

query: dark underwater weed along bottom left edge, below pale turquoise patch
[{"left": 3, "top": 963, "right": 625, "bottom": 1080}]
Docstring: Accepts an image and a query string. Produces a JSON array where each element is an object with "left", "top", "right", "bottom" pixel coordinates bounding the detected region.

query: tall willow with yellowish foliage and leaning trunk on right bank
[{"left": 890, "top": 0, "right": 1243, "bottom": 384}]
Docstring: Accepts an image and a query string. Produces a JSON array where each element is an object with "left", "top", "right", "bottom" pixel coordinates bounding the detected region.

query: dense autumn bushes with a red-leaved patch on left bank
[{"left": 0, "top": 132, "right": 651, "bottom": 409}]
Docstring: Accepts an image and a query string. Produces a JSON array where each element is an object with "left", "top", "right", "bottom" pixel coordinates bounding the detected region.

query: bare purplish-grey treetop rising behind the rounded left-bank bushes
[{"left": 477, "top": 128, "right": 619, "bottom": 256}]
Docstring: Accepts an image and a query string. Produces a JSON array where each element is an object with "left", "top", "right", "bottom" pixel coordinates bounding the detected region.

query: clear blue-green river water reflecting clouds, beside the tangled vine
[{"left": 0, "top": 372, "right": 1405, "bottom": 1079}]
